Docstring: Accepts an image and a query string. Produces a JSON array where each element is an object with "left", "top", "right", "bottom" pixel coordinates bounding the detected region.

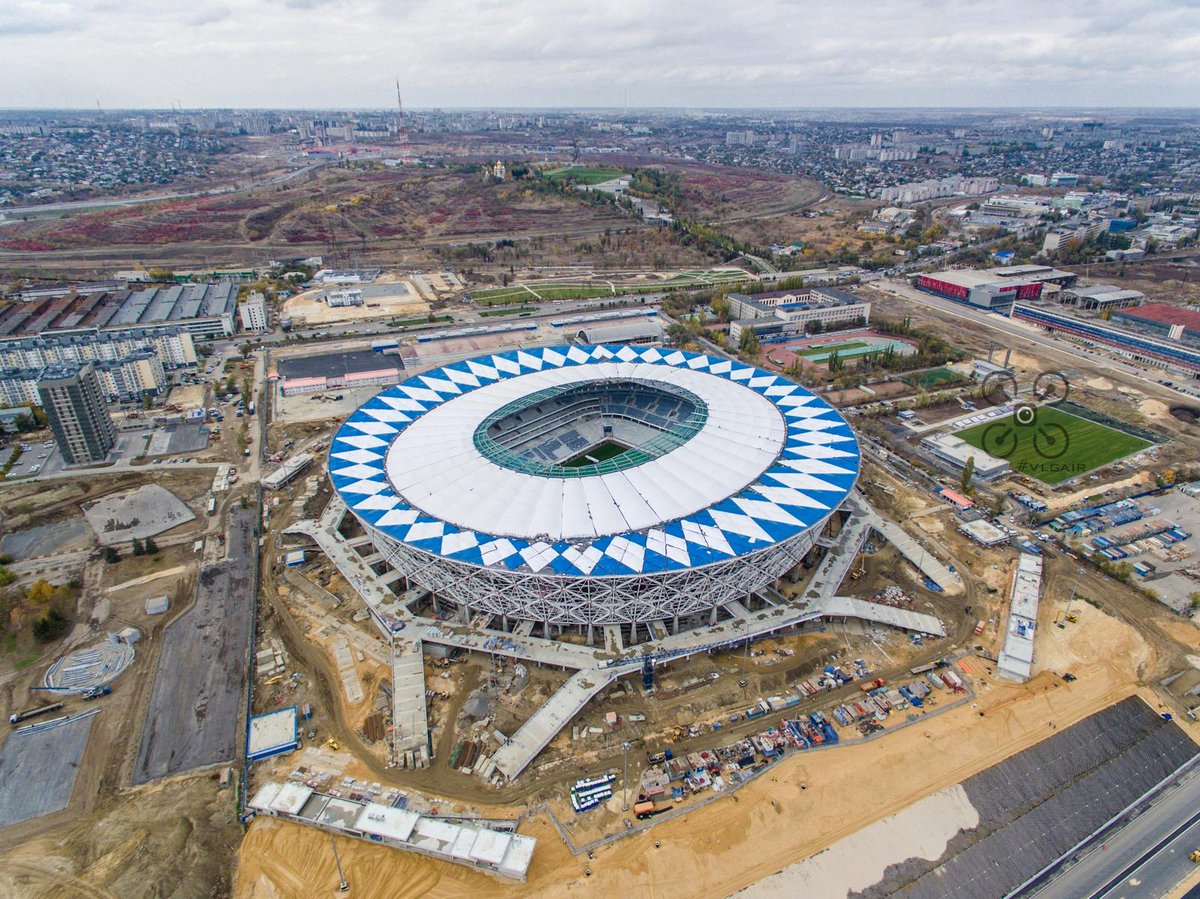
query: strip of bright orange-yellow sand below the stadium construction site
[{"left": 234, "top": 585, "right": 1196, "bottom": 898}]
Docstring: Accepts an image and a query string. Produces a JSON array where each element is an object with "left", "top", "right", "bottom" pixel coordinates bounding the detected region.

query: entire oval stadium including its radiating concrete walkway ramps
[{"left": 286, "top": 346, "right": 961, "bottom": 781}]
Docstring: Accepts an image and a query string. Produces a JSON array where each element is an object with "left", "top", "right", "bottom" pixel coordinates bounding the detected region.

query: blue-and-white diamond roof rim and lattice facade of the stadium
[{"left": 328, "top": 346, "right": 860, "bottom": 625}]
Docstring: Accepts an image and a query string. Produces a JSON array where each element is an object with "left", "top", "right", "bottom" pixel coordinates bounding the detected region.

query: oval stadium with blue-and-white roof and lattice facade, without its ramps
[{"left": 329, "top": 346, "right": 859, "bottom": 636}]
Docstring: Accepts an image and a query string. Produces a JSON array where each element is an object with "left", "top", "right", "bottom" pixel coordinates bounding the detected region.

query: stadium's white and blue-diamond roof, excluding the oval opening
[{"left": 329, "top": 346, "right": 859, "bottom": 576}]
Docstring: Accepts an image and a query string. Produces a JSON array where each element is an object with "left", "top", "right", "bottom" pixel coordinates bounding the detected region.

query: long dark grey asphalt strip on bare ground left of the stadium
[{"left": 133, "top": 510, "right": 257, "bottom": 784}]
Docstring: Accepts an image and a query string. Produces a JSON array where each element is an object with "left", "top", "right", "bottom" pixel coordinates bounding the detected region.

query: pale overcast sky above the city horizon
[{"left": 0, "top": 0, "right": 1200, "bottom": 108}]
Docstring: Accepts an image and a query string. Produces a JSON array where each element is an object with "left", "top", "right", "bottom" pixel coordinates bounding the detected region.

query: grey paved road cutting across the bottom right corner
[{"left": 1027, "top": 768, "right": 1200, "bottom": 899}]
